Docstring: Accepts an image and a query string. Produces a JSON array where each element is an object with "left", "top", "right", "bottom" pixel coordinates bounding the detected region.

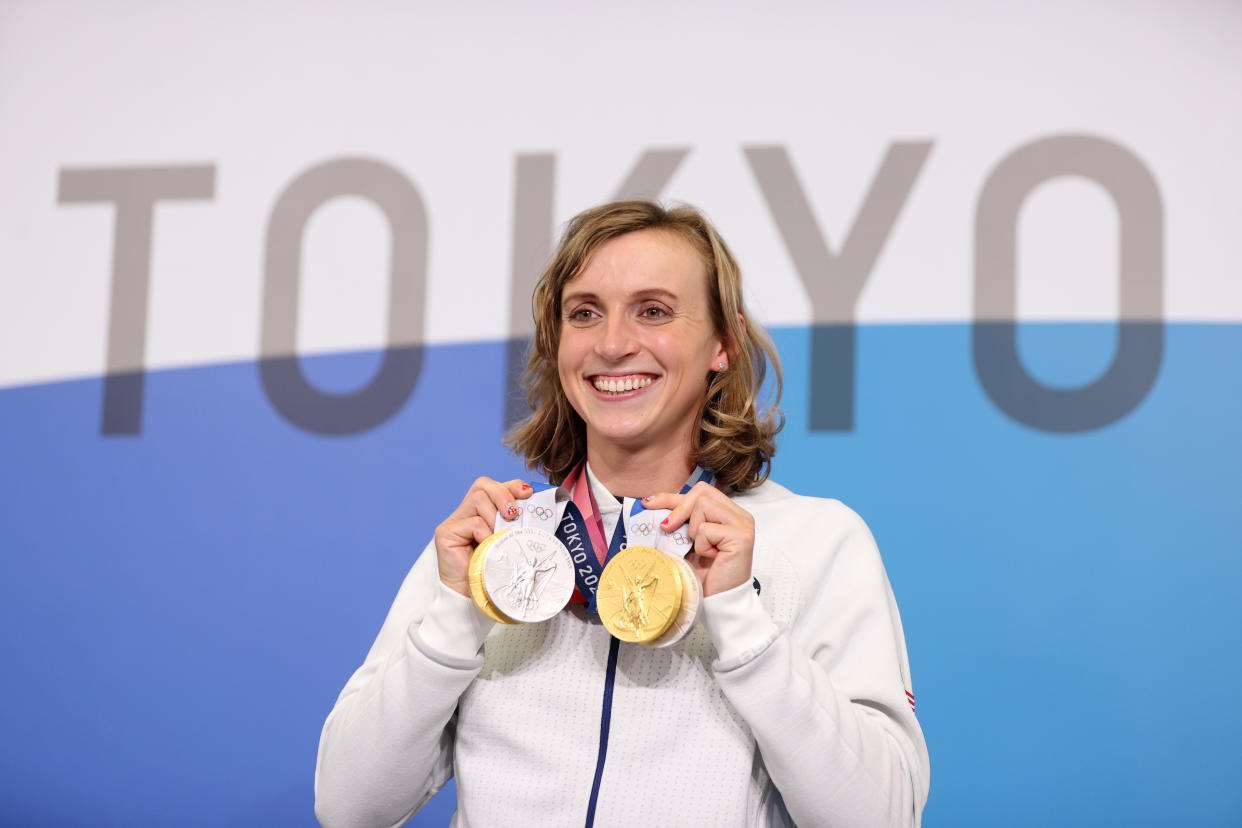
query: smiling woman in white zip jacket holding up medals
[{"left": 315, "top": 202, "right": 928, "bottom": 827}]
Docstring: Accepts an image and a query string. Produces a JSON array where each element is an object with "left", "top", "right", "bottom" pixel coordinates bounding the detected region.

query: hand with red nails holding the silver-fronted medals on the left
[{"left": 436, "top": 477, "right": 534, "bottom": 598}]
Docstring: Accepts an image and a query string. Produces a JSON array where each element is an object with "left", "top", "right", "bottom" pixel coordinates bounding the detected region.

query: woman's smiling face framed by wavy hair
[{"left": 556, "top": 230, "right": 728, "bottom": 454}]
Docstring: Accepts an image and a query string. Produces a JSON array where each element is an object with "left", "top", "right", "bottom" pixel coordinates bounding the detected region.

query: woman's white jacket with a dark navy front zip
[{"left": 315, "top": 482, "right": 929, "bottom": 828}]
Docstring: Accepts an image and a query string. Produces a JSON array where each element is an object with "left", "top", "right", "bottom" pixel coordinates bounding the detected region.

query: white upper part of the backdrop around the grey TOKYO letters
[{"left": 0, "top": 1, "right": 1242, "bottom": 385}]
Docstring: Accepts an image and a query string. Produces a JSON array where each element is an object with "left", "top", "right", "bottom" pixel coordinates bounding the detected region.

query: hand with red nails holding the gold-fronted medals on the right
[{"left": 642, "top": 482, "right": 755, "bottom": 596}]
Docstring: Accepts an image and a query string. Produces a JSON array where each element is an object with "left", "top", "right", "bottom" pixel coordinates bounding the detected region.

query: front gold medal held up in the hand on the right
[{"left": 595, "top": 546, "right": 683, "bottom": 644}]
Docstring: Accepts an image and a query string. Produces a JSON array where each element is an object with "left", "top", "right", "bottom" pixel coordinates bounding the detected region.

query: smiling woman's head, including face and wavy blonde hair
[{"left": 510, "top": 201, "right": 780, "bottom": 494}]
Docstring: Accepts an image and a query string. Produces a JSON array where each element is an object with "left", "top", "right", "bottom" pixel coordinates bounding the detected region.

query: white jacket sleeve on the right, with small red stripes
[{"left": 704, "top": 500, "right": 929, "bottom": 828}]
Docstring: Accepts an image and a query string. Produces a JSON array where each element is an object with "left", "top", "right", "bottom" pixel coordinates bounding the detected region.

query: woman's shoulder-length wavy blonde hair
[{"left": 505, "top": 201, "right": 784, "bottom": 490}]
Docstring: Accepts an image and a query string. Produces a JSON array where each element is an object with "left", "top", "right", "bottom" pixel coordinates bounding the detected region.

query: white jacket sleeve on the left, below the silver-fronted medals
[{"left": 314, "top": 544, "right": 493, "bottom": 828}]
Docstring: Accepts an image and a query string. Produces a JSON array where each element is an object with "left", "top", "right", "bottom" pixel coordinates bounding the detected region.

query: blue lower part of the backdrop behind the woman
[{"left": 0, "top": 324, "right": 1242, "bottom": 828}]
